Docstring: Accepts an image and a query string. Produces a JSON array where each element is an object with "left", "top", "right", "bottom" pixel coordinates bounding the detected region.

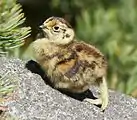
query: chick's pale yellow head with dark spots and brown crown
[{"left": 40, "top": 17, "right": 75, "bottom": 45}]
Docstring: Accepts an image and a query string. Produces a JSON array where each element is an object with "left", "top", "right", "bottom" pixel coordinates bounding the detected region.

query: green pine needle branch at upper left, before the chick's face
[{"left": 0, "top": 0, "right": 30, "bottom": 54}]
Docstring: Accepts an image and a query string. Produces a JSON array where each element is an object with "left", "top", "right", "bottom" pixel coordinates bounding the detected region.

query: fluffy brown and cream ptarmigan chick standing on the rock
[{"left": 33, "top": 17, "right": 108, "bottom": 110}]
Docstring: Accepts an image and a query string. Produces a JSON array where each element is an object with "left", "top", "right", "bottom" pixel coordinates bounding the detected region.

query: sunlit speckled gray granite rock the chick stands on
[{"left": 0, "top": 58, "right": 137, "bottom": 120}]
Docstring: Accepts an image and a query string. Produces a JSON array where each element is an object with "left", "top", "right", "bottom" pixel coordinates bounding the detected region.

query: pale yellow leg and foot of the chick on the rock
[{"left": 84, "top": 77, "right": 108, "bottom": 110}]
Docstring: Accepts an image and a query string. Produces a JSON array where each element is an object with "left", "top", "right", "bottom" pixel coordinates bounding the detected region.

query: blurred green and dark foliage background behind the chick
[{"left": 0, "top": 0, "right": 137, "bottom": 97}]
